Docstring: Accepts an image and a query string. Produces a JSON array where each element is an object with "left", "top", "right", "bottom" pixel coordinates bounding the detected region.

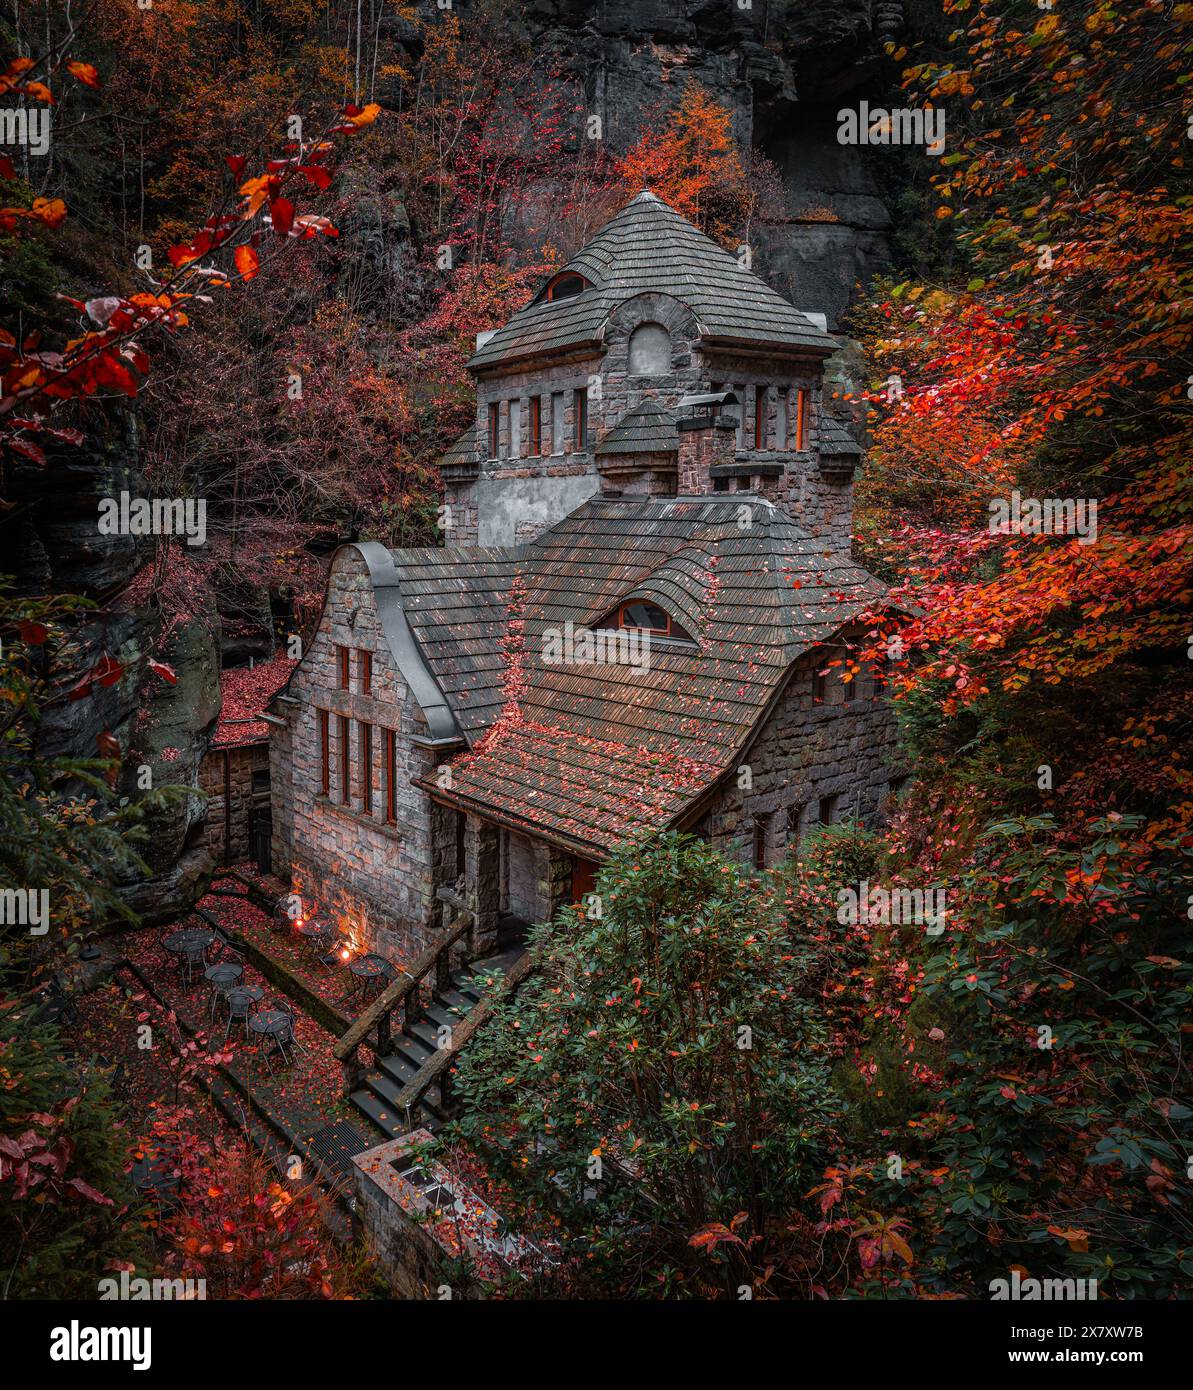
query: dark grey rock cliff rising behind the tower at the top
[{"left": 527, "top": 0, "right": 904, "bottom": 328}]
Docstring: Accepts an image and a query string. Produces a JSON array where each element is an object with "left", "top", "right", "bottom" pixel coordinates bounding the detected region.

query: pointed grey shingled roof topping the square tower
[{"left": 469, "top": 192, "right": 836, "bottom": 370}]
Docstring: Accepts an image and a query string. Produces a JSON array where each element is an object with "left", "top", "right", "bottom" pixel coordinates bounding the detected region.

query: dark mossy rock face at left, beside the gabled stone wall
[{"left": 6, "top": 410, "right": 220, "bottom": 923}]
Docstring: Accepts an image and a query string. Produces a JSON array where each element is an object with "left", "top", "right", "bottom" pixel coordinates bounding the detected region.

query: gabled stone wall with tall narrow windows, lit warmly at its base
[{"left": 270, "top": 548, "right": 444, "bottom": 956}]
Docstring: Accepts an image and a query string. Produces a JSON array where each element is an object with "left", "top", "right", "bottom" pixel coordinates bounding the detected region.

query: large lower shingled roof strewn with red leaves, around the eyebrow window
[{"left": 395, "top": 498, "right": 883, "bottom": 849}]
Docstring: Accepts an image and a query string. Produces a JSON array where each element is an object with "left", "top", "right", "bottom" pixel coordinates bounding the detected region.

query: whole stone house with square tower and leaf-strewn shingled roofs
[{"left": 270, "top": 192, "right": 894, "bottom": 954}]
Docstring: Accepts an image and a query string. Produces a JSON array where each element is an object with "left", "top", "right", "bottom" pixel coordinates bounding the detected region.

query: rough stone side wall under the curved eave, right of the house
[{"left": 698, "top": 633, "right": 901, "bottom": 866}]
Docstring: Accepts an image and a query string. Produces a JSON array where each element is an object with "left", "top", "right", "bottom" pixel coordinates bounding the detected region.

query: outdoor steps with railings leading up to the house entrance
[{"left": 349, "top": 923, "right": 524, "bottom": 1143}]
